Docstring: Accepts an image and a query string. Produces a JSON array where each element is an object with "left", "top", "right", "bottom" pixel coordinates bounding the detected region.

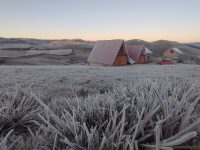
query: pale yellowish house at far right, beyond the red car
[{"left": 163, "top": 48, "right": 183, "bottom": 61}]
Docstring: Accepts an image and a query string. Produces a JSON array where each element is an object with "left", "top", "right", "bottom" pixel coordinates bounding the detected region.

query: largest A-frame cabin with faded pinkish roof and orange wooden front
[{"left": 88, "top": 40, "right": 128, "bottom": 66}]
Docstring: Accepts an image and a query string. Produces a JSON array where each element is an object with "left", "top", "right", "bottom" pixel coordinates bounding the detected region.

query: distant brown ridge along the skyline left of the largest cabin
[{"left": 0, "top": 38, "right": 94, "bottom": 50}]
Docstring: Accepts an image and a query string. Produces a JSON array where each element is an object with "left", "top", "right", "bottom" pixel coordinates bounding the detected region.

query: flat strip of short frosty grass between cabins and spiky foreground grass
[{"left": 0, "top": 65, "right": 200, "bottom": 95}]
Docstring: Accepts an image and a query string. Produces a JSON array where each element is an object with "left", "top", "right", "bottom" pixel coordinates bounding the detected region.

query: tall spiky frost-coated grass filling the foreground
[{"left": 0, "top": 78, "right": 200, "bottom": 150}]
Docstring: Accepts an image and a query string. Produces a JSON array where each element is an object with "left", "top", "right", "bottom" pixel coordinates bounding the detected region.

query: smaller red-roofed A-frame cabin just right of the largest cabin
[{"left": 126, "top": 45, "right": 152, "bottom": 64}]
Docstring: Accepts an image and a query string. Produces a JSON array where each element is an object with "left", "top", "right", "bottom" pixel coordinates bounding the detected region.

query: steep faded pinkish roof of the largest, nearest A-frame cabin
[{"left": 88, "top": 40, "right": 124, "bottom": 65}]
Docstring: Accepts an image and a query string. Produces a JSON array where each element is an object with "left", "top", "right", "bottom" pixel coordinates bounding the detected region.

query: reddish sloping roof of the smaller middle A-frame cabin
[{"left": 126, "top": 45, "right": 144, "bottom": 63}]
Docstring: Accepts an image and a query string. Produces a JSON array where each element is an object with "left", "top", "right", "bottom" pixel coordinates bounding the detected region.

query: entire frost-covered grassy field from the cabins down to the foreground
[{"left": 0, "top": 65, "right": 200, "bottom": 150}]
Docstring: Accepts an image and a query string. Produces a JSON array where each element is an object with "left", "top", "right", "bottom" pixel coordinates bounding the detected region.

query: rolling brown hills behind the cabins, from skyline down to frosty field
[{"left": 0, "top": 38, "right": 200, "bottom": 65}]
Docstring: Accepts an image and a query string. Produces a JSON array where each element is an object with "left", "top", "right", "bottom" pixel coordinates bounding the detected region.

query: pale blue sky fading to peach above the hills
[{"left": 0, "top": 0, "right": 200, "bottom": 42}]
